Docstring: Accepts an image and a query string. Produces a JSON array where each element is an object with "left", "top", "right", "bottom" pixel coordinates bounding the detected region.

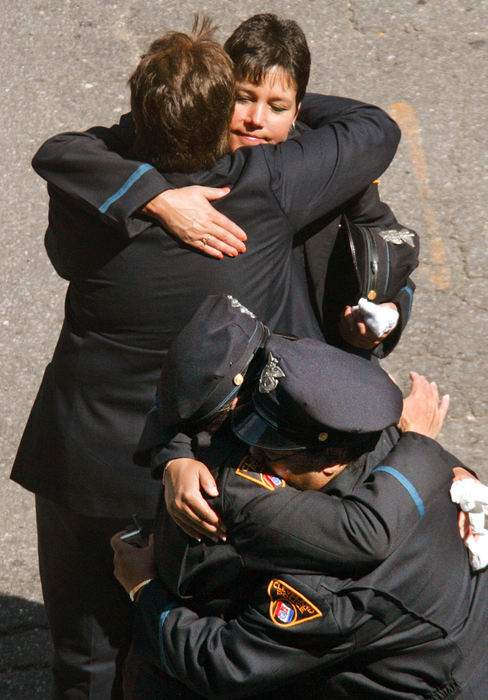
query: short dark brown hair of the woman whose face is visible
[{"left": 224, "top": 13, "right": 310, "bottom": 105}]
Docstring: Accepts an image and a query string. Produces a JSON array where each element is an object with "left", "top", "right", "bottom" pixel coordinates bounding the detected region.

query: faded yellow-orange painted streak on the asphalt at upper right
[{"left": 390, "top": 102, "right": 451, "bottom": 289}]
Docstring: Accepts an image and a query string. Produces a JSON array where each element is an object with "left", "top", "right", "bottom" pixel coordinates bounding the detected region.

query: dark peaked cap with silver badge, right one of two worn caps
[{"left": 232, "top": 336, "right": 403, "bottom": 450}]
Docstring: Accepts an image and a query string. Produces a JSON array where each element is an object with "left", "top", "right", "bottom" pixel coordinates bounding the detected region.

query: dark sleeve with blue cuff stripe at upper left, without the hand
[{"left": 32, "top": 115, "right": 172, "bottom": 238}]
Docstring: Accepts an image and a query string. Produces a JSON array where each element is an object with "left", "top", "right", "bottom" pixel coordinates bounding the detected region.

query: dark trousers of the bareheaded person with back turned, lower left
[{"left": 36, "top": 496, "right": 144, "bottom": 700}]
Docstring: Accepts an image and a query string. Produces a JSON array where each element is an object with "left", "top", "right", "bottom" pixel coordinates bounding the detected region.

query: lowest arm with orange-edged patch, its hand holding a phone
[{"left": 111, "top": 533, "right": 348, "bottom": 698}]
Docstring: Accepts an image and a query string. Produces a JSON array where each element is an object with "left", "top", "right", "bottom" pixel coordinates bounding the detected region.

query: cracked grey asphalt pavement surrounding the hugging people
[{"left": 0, "top": 0, "right": 488, "bottom": 700}]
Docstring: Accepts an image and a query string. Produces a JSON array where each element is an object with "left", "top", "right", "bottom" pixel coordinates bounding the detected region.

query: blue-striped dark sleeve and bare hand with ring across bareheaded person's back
[{"left": 32, "top": 114, "right": 246, "bottom": 258}]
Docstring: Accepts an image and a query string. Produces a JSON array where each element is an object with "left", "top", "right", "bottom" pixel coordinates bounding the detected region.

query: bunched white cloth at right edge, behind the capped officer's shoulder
[{"left": 451, "top": 479, "right": 488, "bottom": 571}]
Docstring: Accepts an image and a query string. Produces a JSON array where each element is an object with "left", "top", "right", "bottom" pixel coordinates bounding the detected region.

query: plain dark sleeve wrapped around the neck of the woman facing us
[{"left": 265, "top": 94, "right": 400, "bottom": 231}]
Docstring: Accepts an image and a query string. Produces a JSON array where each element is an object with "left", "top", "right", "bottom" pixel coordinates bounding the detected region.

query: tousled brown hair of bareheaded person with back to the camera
[{"left": 129, "top": 17, "right": 235, "bottom": 172}]
